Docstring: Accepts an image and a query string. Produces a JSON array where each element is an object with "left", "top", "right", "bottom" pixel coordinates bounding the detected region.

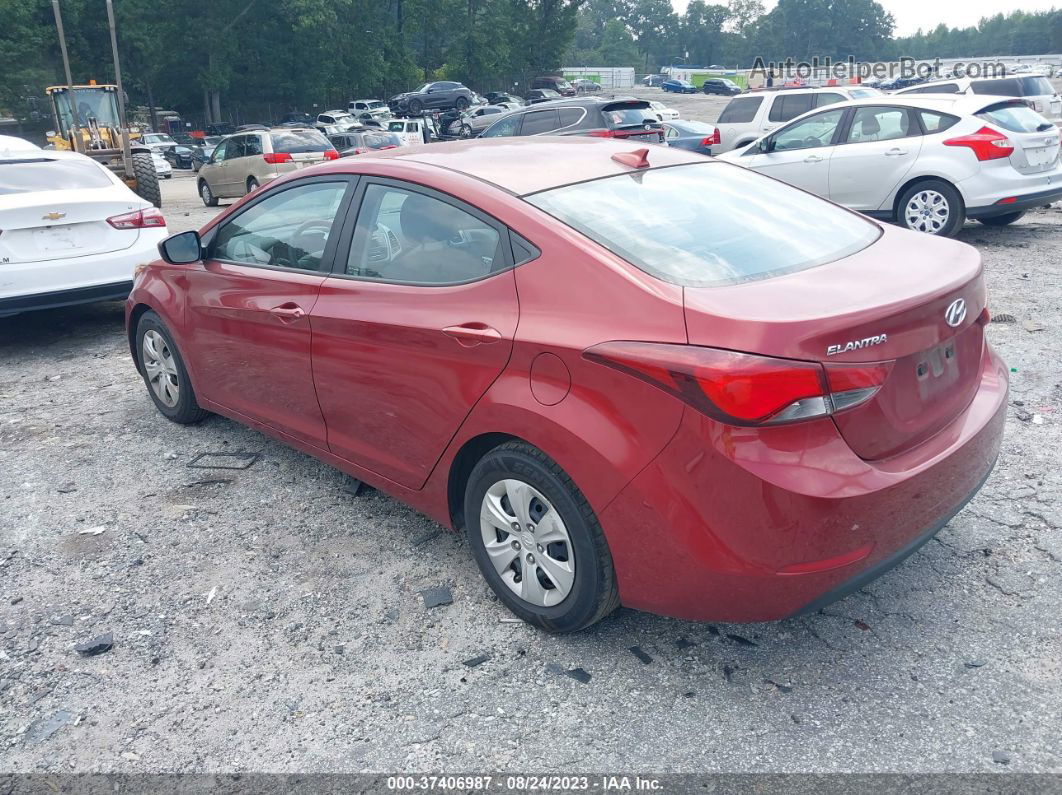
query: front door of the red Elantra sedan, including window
[{"left": 180, "top": 176, "right": 352, "bottom": 449}]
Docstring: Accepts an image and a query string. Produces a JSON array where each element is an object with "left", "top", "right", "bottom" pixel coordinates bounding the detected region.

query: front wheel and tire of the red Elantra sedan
[{"left": 136, "top": 311, "right": 209, "bottom": 425}]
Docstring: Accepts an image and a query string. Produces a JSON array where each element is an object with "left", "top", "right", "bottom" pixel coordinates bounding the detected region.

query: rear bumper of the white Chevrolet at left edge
[{"left": 0, "top": 227, "right": 169, "bottom": 314}]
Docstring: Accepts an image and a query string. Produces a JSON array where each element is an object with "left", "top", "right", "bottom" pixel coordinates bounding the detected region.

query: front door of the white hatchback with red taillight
[{"left": 742, "top": 109, "right": 844, "bottom": 196}]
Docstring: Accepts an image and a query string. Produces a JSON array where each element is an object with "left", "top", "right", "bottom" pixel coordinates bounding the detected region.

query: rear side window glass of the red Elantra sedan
[{"left": 345, "top": 185, "right": 502, "bottom": 286}]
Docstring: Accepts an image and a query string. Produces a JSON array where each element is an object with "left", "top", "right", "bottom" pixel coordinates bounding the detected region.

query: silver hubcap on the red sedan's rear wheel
[{"left": 479, "top": 479, "right": 576, "bottom": 607}]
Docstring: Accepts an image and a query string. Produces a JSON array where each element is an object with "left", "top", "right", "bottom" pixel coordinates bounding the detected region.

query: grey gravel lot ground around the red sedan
[{"left": 0, "top": 134, "right": 1062, "bottom": 773}]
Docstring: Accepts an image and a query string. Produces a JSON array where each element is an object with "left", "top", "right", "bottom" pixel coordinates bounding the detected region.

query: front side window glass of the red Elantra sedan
[{"left": 210, "top": 182, "right": 346, "bottom": 271}]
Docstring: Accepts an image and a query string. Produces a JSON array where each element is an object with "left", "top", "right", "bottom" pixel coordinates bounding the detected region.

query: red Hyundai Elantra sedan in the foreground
[{"left": 126, "top": 137, "right": 1007, "bottom": 632}]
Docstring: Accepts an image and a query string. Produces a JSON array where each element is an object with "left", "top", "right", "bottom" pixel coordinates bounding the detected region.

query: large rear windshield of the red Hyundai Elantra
[{"left": 527, "top": 162, "right": 880, "bottom": 287}]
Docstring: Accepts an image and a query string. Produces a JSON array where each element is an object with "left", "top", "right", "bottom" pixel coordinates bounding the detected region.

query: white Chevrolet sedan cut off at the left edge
[{"left": 0, "top": 150, "right": 169, "bottom": 316}]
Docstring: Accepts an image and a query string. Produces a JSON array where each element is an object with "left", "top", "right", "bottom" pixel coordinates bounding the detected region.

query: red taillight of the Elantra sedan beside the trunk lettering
[{"left": 583, "top": 342, "right": 892, "bottom": 426}]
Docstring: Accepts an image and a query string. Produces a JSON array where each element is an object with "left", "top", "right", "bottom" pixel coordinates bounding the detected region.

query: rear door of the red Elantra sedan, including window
[{"left": 310, "top": 178, "right": 519, "bottom": 488}]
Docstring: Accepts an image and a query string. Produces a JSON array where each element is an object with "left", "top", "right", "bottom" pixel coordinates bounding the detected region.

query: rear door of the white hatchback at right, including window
[{"left": 828, "top": 105, "right": 922, "bottom": 210}]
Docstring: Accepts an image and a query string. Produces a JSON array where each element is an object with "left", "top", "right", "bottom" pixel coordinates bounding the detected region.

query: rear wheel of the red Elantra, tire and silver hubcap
[{"left": 464, "top": 442, "right": 619, "bottom": 633}]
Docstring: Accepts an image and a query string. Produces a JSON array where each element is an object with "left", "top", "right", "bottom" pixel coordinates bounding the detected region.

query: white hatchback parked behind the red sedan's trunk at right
[{"left": 720, "top": 94, "right": 1062, "bottom": 236}]
